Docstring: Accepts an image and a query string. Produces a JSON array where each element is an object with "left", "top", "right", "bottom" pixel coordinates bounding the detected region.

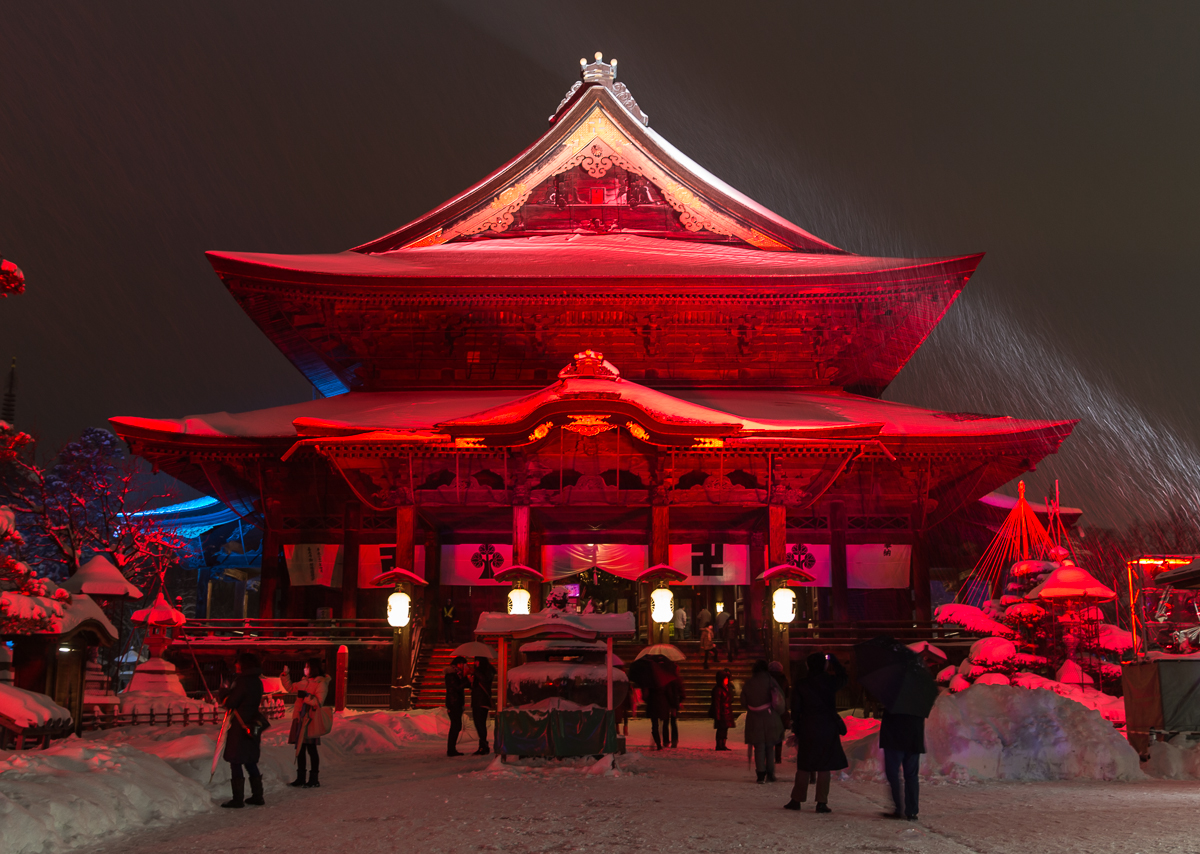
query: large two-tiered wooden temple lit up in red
[{"left": 112, "top": 60, "right": 1074, "bottom": 662}]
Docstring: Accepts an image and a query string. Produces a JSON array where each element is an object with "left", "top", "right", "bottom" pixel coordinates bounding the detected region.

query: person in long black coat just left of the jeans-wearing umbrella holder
[{"left": 784, "top": 652, "right": 850, "bottom": 812}]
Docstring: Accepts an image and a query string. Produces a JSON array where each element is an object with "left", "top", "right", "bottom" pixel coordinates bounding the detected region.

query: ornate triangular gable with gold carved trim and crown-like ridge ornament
[{"left": 355, "top": 61, "right": 845, "bottom": 254}]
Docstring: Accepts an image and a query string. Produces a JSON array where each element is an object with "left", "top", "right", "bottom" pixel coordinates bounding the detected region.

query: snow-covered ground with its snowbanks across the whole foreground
[{"left": 7, "top": 686, "right": 1200, "bottom": 854}]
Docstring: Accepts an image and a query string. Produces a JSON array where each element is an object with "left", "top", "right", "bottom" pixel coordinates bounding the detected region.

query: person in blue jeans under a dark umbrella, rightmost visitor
[{"left": 854, "top": 637, "right": 937, "bottom": 822}]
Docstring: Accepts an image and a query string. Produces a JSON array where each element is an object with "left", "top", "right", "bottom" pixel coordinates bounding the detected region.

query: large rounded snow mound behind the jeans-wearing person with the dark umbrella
[{"left": 844, "top": 684, "right": 1145, "bottom": 781}]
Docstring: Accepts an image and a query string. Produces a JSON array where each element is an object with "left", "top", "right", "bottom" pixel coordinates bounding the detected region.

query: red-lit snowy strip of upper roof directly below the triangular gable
[{"left": 206, "top": 234, "right": 979, "bottom": 288}]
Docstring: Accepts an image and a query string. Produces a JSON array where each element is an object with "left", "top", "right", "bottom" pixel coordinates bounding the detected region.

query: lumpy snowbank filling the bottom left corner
[{"left": 0, "top": 738, "right": 211, "bottom": 854}]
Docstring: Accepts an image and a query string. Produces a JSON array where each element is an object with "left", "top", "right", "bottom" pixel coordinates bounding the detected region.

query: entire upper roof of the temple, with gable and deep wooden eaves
[{"left": 201, "top": 59, "right": 982, "bottom": 396}]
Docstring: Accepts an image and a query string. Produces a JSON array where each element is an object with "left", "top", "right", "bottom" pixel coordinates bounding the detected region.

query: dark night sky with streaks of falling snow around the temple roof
[{"left": 0, "top": 0, "right": 1200, "bottom": 524}]
